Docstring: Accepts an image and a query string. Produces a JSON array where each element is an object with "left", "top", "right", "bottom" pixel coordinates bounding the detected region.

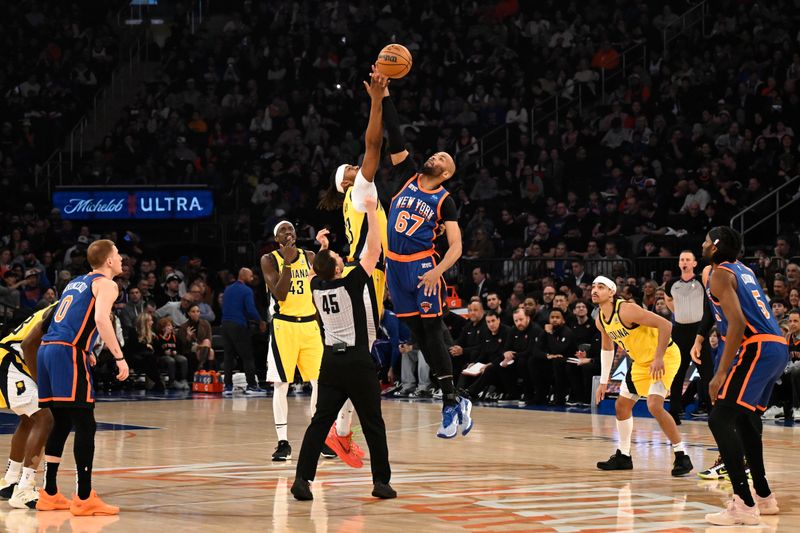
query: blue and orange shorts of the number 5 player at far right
[{"left": 717, "top": 334, "right": 789, "bottom": 412}]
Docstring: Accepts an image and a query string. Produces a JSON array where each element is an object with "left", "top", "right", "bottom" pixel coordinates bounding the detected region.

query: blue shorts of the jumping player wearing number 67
[{"left": 386, "top": 256, "right": 447, "bottom": 318}]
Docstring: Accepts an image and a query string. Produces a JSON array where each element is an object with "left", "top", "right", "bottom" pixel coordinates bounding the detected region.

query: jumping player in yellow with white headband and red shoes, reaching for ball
[{"left": 319, "top": 69, "right": 388, "bottom": 468}]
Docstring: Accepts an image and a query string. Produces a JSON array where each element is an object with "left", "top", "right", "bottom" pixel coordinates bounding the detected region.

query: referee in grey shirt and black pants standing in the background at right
[{"left": 665, "top": 250, "right": 713, "bottom": 425}]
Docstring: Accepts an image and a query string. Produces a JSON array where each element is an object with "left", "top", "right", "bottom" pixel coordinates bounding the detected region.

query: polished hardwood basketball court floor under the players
[{"left": 0, "top": 396, "right": 800, "bottom": 533}]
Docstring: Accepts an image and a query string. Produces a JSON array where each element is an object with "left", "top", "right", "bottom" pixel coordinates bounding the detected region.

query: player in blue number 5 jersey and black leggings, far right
[{"left": 703, "top": 226, "right": 789, "bottom": 526}]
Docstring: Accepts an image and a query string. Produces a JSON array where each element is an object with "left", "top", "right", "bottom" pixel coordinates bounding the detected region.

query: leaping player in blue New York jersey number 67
[{"left": 383, "top": 83, "right": 472, "bottom": 439}]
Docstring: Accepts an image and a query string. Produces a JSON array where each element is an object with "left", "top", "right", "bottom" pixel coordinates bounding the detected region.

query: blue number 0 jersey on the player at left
[{"left": 42, "top": 274, "right": 102, "bottom": 352}]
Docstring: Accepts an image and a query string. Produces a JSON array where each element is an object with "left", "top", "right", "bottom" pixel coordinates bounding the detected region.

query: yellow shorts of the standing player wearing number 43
[{"left": 267, "top": 315, "right": 323, "bottom": 383}]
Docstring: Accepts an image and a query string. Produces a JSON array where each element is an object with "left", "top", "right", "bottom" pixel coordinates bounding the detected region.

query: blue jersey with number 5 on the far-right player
[{"left": 706, "top": 261, "right": 783, "bottom": 341}]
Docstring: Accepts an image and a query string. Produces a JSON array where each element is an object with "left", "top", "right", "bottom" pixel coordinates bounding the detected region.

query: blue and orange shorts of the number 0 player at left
[{"left": 36, "top": 341, "right": 94, "bottom": 408}]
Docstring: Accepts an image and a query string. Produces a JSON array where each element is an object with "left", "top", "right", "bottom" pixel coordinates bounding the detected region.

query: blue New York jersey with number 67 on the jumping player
[{"left": 387, "top": 174, "right": 449, "bottom": 256}]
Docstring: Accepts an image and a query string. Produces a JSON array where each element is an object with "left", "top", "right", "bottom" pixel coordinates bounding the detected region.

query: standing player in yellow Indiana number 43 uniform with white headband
[{"left": 261, "top": 220, "right": 323, "bottom": 461}]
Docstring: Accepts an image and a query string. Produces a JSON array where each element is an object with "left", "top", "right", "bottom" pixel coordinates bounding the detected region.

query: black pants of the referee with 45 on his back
[{"left": 296, "top": 346, "right": 392, "bottom": 483}]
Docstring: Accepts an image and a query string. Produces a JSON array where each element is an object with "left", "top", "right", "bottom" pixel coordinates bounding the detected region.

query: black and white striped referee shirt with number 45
[{"left": 311, "top": 263, "right": 378, "bottom": 351}]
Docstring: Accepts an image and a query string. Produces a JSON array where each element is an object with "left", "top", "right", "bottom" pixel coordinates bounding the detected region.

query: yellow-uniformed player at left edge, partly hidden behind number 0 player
[{"left": 0, "top": 302, "right": 57, "bottom": 510}]
